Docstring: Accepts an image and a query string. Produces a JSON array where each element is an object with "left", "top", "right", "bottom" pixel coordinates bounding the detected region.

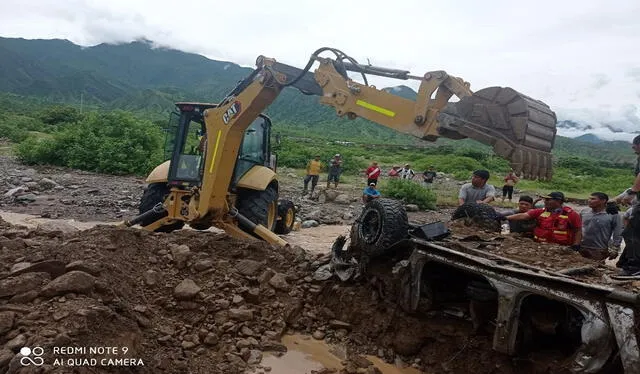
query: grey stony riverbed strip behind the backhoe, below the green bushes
[{"left": 0, "top": 155, "right": 451, "bottom": 227}]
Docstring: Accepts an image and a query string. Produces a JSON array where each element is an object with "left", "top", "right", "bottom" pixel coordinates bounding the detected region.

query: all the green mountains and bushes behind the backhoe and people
[{"left": 0, "top": 38, "right": 634, "bottom": 196}]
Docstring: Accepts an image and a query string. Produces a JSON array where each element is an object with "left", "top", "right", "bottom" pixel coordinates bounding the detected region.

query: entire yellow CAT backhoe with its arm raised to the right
[{"left": 125, "top": 47, "right": 556, "bottom": 245}]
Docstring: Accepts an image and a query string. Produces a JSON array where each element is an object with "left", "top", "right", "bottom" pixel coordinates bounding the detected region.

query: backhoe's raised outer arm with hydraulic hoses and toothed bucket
[{"left": 256, "top": 49, "right": 557, "bottom": 180}]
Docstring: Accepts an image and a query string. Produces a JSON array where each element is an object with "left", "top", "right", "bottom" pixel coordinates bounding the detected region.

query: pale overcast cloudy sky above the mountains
[{"left": 0, "top": 0, "right": 640, "bottom": 139}]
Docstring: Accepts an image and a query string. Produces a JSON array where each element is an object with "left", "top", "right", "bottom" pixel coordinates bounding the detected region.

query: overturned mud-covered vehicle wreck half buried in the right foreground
[{"left": 334, "top": 198, "right": 640, "bottom": 373}]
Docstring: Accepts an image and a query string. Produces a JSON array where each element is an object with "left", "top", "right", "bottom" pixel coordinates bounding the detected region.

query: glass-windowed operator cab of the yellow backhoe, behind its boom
[{"left": 164, "top": 102, "right": 275, "bottom": 188}]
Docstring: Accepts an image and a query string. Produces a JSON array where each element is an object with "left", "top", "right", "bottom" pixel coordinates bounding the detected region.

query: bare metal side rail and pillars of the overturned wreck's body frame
[{"left": 403, "top": 237, "right": 640, "bottom": 373}]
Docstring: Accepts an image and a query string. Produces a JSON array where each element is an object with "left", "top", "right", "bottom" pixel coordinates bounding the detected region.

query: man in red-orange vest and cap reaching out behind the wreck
[{"left": 506, "top": 192, "right": 582, "bottom": 251}]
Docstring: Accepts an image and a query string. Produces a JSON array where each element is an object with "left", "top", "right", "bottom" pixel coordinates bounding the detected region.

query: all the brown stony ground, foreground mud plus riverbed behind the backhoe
[{"left": 0, "top": 156, "right": 600, "bottom": 374}]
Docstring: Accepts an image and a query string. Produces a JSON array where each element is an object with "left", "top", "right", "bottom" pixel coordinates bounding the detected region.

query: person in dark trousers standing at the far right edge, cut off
[{"left": 615, "top": 135, "right": 640, "bottom": 277}]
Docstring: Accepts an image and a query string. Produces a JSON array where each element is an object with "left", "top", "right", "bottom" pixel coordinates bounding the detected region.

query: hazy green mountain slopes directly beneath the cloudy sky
[{"left": 0, "top": 38, "right": 633, "bottom": 164}]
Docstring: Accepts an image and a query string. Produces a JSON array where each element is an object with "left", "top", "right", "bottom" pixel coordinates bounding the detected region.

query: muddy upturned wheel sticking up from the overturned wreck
[{"left": 357, "top": 199, "right": 409, "bottom": 257}]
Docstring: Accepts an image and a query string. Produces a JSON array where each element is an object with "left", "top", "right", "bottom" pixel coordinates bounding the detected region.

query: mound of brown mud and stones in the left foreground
[{"left": 0, "top": 216, "right": 324, "bottom": 373}]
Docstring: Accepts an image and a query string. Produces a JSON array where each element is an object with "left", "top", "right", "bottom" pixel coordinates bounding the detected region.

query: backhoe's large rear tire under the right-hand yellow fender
[{"left": 236, "top": 185, "right": 278, "bottom": 232}]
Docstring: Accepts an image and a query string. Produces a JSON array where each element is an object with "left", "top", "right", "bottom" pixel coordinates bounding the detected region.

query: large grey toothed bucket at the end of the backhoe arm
[{"left": 438, "top": 87, "right": 557, "bottom": 180}]
